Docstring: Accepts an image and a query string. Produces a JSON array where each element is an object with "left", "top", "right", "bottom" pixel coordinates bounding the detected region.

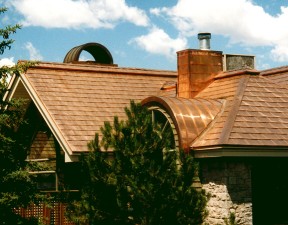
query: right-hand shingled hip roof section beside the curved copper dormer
[{"left": 191, "top": 67, "right": 288, "bottom": 155}]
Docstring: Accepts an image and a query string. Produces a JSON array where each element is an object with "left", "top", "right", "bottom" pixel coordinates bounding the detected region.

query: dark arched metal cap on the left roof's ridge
[{"left": 63, "top": 42, "right": 113, "bottom": 64}]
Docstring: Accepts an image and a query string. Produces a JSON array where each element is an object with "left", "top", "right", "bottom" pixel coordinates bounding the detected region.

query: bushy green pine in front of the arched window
[{"left": 72, "top": 101, "right": 207, "bottom": 225}]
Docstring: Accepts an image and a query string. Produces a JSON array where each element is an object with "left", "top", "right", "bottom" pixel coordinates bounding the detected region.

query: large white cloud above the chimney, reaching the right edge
[{"left": 150, "top": 0, "right": 288, "bottom": 61}]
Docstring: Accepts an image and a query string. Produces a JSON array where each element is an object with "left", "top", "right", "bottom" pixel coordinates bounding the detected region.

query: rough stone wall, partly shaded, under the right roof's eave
[{"left": 200, "top": 158, "right": 252, "bottom": 225}]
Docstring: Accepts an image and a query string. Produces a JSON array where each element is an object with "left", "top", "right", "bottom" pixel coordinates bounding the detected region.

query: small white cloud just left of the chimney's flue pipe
[{"left": 130, "top": 27, "right": 187, "bottom": 58}]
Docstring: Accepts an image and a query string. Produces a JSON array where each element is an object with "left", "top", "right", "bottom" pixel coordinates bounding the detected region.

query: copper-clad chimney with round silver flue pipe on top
[{"left": 177, "top": 33, "right": 223, "bottom": 98}]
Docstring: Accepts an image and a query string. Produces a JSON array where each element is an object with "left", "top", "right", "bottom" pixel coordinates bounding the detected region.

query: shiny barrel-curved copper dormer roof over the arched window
[{"left": 142, "top": 96, "right": 223, "bottom": 150}]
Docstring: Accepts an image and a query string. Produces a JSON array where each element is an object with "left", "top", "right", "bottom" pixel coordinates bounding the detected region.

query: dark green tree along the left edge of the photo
[{"left": 0, "top": 8, "right": 43, "bottom": 224}]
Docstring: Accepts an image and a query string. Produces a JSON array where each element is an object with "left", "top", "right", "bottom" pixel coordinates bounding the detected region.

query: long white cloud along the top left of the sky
[{"left": 10, "top": 0, "right": 149, "bottom": 29}]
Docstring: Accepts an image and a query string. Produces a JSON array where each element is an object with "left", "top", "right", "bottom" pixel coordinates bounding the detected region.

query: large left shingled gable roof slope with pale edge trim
[{"left": 16, "top": 63, "right": 177, "bottom": 159}]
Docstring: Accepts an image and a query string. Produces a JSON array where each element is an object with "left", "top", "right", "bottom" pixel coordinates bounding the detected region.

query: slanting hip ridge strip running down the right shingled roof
[{"left": 219, "top": 76, "right": 250, "bottom": 144}]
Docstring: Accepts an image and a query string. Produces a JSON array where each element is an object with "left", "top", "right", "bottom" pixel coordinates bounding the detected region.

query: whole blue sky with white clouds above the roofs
[{"left": 0, "top": 0, "right": 288, "bottom": 70}]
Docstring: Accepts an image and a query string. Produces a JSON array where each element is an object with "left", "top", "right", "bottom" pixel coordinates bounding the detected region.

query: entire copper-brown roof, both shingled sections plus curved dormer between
[{"left": 13, "top": 58, "right": 288, "bottom": 157}]
